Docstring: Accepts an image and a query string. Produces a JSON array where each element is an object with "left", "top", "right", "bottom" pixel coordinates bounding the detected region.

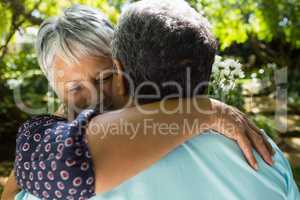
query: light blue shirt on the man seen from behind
[{"left": 16, "top": 133, "right": 300, "bottom": 200}]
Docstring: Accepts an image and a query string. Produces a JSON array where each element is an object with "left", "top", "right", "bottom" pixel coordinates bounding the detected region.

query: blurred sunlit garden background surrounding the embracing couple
[{"left": 0, "top": 0, "right": 300, "bottom": 194}]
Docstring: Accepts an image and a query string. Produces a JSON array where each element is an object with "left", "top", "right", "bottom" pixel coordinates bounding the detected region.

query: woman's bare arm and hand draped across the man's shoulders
[{"left": 87, "top": 97, "right": 272, "bottom": 192}]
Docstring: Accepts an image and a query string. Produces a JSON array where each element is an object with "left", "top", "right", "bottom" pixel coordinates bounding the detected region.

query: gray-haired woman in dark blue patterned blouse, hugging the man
[{"left": 3, "top": 2, "right": 278, "bottom": 199}]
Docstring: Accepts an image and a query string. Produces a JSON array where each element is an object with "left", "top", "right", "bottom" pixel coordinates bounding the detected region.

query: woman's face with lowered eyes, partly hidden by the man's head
[{"left": 52, "top": 56, "right": 113, "bottom": 112}]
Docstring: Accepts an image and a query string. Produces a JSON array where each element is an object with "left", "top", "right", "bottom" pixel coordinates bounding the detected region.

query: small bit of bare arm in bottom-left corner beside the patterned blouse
[{"left": 1, "top": 171, "right": 20, "bottom": 200}]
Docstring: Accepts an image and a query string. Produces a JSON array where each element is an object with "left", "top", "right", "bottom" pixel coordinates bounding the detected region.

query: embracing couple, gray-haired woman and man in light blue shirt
[{"left": 3, "top": 0, "right": 300, "bottom": 200}]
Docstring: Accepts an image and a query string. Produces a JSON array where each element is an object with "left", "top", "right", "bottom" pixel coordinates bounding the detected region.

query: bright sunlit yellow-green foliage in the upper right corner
[{"left": 192, "top": 0, "right": 300, "bottom": 49}]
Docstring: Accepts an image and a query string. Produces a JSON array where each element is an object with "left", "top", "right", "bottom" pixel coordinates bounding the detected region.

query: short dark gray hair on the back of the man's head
[{"left": 112, "top": 0, "right": 217, "bottom": 103}]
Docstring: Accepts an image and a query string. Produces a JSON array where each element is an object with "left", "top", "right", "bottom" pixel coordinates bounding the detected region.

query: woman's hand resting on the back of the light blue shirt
[{"left": 211, "top": 99, "right": 274, "bottom": 170}]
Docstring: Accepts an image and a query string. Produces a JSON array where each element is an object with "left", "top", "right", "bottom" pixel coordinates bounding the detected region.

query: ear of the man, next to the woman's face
[{"left": 113, "top": 59, "right": 127, "bottom": 96}]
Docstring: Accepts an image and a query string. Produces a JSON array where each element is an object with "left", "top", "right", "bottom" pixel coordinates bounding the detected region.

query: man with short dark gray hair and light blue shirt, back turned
[{"left": 84, "top": 0, "right": 300, "bottom": 200}]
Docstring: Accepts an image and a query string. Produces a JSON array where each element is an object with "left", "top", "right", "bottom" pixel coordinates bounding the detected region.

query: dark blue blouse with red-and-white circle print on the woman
[{"left": 14, "top": 110, "right": 95, "bottom": 200}]
